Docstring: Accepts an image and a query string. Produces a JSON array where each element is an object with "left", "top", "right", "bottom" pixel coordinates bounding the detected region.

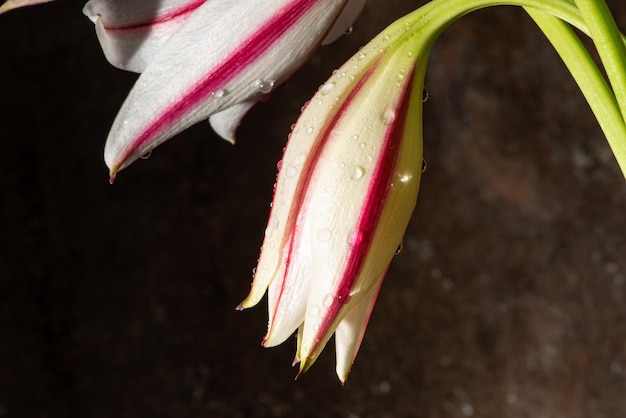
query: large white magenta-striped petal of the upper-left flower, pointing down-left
[{"left": 105, "top": 0, "right": 345, "bottom": 176}]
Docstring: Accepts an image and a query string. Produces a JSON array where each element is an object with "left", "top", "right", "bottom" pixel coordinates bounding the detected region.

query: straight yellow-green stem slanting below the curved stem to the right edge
[{"left": 526, "top": 8, "right": 626, "bottom": 177}]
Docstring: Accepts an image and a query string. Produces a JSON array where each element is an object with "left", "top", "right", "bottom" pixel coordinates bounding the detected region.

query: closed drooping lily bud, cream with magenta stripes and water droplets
[{"left": 240, "top": 22, "right": 425, "bottom": 382}]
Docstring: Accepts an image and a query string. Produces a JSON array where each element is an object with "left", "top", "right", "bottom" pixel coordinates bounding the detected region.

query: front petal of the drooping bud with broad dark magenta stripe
[{"left": 299, "top": 46, "right": 422, "bottom": 370}]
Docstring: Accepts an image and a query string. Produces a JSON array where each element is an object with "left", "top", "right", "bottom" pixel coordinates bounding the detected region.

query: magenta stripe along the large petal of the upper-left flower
[{"left": 119, "top": 0, "right": 320, "bottom": 168}]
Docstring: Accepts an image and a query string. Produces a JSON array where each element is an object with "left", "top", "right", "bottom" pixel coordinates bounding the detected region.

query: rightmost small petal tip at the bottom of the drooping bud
[{"left": 335, "top": 277, "right": 383, "bottom": 383}]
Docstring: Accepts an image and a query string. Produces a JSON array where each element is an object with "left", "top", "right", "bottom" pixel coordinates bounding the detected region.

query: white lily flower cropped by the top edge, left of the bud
[{"left": 84, "top": 0, "right": 364, "bottom": 179}]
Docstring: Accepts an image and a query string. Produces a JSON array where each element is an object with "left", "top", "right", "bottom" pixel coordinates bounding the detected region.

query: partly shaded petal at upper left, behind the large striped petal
[{"left": 83, "top": 0, "right": 207, "bottom": 72}]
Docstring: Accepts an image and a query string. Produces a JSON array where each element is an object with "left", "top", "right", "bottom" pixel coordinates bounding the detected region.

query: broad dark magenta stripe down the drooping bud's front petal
[{"left": 317, "top": 61, "right": 415, "bottom": 350}]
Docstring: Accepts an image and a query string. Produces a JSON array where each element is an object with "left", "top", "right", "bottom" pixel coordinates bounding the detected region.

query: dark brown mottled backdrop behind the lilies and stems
[{"left": 0, "top": 0, "right": 626, "bottom": 418}]
